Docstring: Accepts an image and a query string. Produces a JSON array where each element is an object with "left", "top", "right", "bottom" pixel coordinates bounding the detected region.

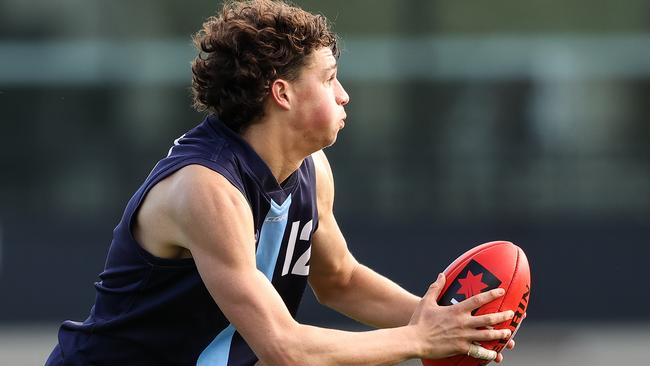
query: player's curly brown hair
[{"left": 192, "top": 0, "right": 339, "bottom": 132}]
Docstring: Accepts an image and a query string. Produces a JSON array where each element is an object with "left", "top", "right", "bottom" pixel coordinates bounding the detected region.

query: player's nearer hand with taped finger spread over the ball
[{"left": 409, "top": 273, "right": 514, "bottom": 361}]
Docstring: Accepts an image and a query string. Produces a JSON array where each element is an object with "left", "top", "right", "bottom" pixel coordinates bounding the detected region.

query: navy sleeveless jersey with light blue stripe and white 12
[{"left": 46, "top": 116, "right": 318, "bottom": 366}]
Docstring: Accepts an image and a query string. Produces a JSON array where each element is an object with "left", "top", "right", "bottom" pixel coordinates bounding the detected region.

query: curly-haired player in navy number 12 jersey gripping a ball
[{"left": 47, "top": 0, "right": 513, "bottom": 366}]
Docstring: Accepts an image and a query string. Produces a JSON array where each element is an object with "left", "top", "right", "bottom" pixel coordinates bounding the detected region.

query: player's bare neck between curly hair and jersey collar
[{"left": 242, "top": 121, "right": 310, "bottom": 183}]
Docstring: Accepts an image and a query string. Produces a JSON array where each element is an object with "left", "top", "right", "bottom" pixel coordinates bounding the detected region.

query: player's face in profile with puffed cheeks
[{"left": 293, "top": 48, "right": 350, "bottom": 150}]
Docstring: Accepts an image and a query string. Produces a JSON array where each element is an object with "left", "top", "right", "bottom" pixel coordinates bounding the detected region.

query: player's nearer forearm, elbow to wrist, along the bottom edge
[{"left": 262, "top": 324, "right": 421, "bottom": 366}]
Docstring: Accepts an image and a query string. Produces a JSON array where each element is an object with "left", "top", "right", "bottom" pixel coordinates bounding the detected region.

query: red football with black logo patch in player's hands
[{"left": 422, "top": 241, "right": 530, "bottom": 366}]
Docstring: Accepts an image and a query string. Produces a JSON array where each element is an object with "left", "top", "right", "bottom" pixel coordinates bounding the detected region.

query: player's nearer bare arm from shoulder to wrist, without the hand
[{"left": 167, "top": 166, "right": 418, "bottom": 365}]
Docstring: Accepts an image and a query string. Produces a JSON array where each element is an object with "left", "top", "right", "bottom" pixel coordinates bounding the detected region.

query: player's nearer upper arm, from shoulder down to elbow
[{"left": 171, "top": 168, "right": 294, "bottom": 357}]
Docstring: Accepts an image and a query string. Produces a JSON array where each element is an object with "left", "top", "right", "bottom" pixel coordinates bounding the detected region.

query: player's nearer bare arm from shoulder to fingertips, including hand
[{"left": 169, "top": 166, "right": 511, "bottom": 366}]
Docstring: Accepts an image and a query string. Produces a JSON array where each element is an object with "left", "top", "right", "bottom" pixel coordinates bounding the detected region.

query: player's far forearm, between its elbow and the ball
[{"left": 316, "top": 264, "right": 420, "bottom": 328}]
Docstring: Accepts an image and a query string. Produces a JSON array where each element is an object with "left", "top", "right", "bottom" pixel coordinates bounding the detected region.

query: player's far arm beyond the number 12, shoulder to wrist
[{"left": 309, "top": 151, "right": 421, "bottom": 328}]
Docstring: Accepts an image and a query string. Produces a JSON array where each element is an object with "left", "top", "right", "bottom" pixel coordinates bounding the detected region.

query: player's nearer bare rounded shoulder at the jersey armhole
[{"left": 134, "top": 165, "right": 252, "bottom": 258}]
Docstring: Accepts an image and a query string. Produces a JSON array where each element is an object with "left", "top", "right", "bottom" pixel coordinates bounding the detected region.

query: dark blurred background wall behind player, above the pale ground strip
[{"left": 0, "top": 0, "right": 650, "bottom": 364}]
